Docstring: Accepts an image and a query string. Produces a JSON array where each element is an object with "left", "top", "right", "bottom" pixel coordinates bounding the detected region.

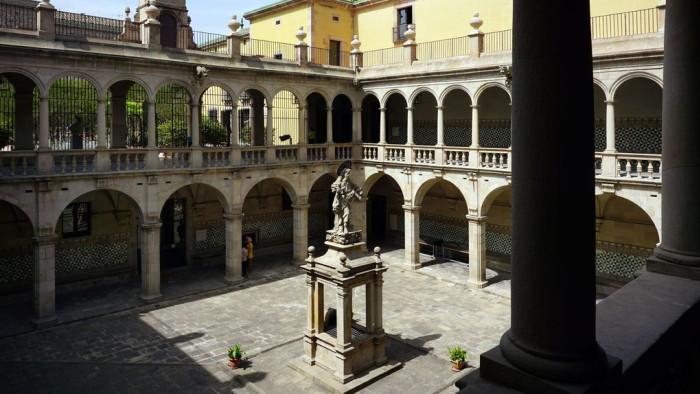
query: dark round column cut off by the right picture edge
[{"left": 647, "top": 0, "right": 700, "bottom": 280}]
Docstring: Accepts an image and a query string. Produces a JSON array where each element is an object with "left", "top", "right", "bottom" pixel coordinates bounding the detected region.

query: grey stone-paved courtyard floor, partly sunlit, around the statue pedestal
[{"left": 0, "top": 249, "right": 510, "bottom": 393}]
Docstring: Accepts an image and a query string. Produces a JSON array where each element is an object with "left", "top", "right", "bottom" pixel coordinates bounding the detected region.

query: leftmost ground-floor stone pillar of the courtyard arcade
[{"left": 32, "top": 234, "right": 58, "bottom": 327}]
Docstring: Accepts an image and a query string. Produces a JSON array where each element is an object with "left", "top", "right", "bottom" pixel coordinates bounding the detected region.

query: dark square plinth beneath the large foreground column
[{"left": 476, "top": 346, "right": 622, "bottom": 394}]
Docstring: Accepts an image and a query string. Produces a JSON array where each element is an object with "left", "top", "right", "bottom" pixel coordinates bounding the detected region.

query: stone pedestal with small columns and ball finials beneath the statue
[{"left": 292, "top": 231, "right": 401, "bottom": 392}]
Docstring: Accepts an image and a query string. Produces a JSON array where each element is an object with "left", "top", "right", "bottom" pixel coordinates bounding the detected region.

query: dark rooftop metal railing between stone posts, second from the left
[{"left": 56, "top": 11, "right": 131, "bottom": 41}]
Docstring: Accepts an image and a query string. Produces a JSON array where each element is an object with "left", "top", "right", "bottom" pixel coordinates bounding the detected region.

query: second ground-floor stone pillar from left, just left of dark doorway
[{"left": 140, "top": 222, "right": 163, "bottom": 302}]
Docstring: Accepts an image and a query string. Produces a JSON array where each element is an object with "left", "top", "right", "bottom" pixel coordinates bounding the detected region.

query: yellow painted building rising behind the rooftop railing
[{"left": 244, "top": 0, "right": 659, "bottom": 52}]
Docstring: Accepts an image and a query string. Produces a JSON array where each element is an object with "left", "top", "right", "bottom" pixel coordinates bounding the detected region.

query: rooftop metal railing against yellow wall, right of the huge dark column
[{"left": 591, "top": 8, "right": 659, "bottom": 40}]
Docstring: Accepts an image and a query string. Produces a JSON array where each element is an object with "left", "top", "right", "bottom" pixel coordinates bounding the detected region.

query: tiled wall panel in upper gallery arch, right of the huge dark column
[{"left": 615, "top": 118, "right": 661, "bottom": 154}]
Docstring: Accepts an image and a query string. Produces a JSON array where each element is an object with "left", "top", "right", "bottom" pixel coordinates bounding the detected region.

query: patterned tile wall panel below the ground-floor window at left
[{"left": 56, "top": 233, "right": 129, "bottom": 276}]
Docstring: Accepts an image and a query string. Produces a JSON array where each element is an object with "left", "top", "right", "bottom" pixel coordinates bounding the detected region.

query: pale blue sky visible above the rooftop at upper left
[{"left": 51, "top": 0, "right": 278, "bottom": 34}]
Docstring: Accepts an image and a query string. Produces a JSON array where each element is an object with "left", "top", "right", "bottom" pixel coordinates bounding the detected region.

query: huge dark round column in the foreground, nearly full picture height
[{"left": 481, "top": 0, "right": 607, "bottom": 392}]
